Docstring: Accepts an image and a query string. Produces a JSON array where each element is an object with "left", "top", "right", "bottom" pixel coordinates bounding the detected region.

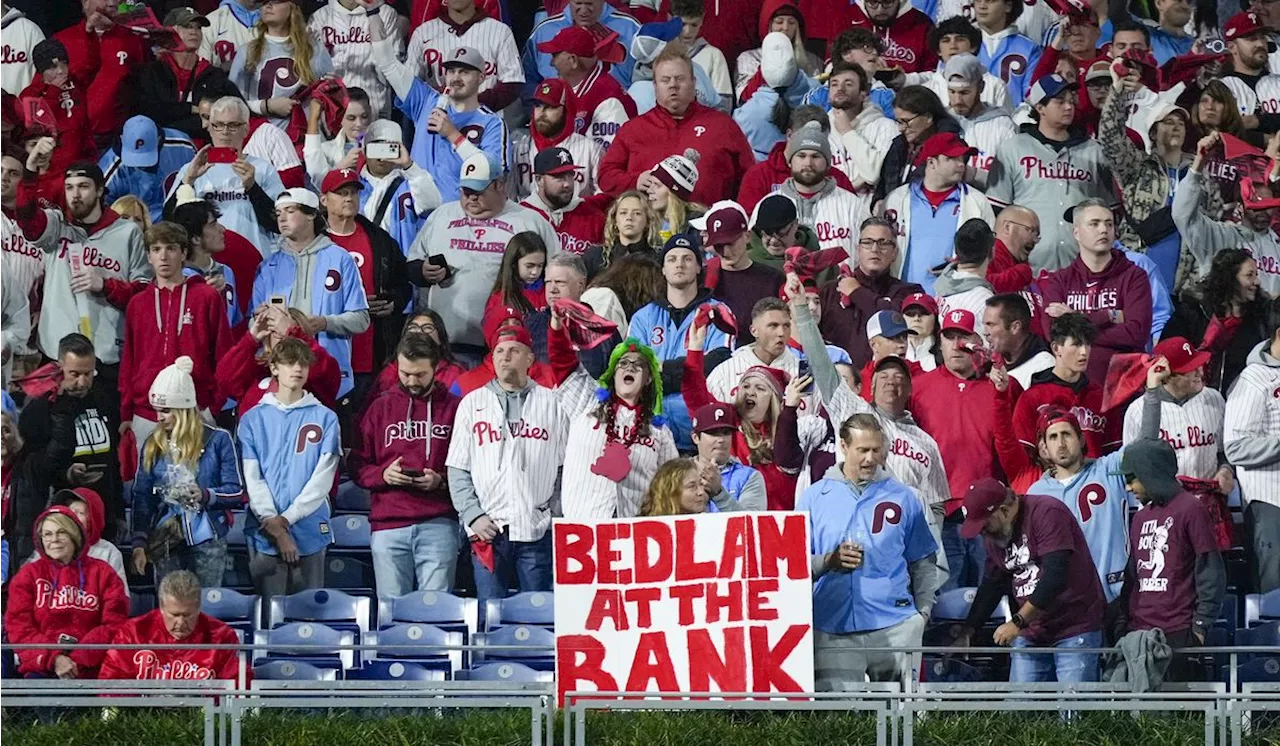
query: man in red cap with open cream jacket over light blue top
[{"left": 884, "top": 132, "right": 996, "bottom": 294}]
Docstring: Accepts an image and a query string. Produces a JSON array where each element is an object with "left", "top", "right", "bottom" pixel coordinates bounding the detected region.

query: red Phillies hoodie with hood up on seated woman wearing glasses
[{"left": 4, "top": 505, "right": 129, "bottom": 674}]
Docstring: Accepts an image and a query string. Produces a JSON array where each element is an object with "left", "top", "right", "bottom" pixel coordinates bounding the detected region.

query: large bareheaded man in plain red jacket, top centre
[{"left": 599, "top": 41, "right": 752, "bottom": 206}]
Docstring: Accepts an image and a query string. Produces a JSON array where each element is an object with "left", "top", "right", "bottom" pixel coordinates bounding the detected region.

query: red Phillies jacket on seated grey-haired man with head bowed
[{"left": 80, "top": 609, "right": 247, "bottom": 681}]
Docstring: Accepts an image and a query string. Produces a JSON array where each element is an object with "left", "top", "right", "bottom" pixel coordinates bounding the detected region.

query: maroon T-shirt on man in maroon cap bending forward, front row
[{"left": 986, "top": 495, "right": 1107, "bottom": 645}]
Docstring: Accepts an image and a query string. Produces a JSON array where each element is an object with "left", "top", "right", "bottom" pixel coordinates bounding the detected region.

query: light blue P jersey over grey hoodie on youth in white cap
[{"left": 252, "top": 233, "right": 370, "bottom": 398}]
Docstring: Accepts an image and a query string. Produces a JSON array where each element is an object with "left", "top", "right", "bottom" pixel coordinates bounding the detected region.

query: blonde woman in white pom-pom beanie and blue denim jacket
[{"left": 132, "top": 357, "right": 244, "bottom": 587}]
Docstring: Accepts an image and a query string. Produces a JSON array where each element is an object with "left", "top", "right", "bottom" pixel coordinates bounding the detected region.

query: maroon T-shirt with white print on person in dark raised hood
[{"left": 1129, "top": 493, "right": 1217, "bottom": 635}]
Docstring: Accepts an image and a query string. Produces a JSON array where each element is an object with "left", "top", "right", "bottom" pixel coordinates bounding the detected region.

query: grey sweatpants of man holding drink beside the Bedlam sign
[{"left": 813, "top": 614, "right": 924, "bottom": 691}]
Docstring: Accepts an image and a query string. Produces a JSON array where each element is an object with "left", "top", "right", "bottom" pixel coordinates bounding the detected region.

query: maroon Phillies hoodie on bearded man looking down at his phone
[{"left": 351, "top": 384, "right": 461, "bottom": 531}]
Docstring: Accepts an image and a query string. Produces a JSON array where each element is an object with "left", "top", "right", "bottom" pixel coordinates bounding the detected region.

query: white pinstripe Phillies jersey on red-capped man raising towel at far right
[{"left": 1124, "top": 388, "right": 1226, "bottom": 479}]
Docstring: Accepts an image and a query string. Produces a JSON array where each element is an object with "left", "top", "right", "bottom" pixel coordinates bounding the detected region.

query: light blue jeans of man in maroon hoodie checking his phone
[{"left": 369, "top": 517, "right": 462, "bottom": 599}]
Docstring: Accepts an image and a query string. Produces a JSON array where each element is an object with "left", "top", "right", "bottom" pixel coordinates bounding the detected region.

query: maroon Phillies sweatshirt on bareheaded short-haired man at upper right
[{"left": 1039, "top": 250, "right": 1151, "bottom": 381}]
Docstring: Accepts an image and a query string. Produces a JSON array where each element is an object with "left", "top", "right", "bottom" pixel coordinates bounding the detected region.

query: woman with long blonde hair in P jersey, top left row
[{"left": 228, "top": 0, "right": 333, "bottom": 129}]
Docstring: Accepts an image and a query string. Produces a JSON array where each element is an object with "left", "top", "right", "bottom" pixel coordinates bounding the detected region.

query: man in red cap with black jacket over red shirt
[{"left": 320, "top": 169, "right": 412, "bottom": 411}]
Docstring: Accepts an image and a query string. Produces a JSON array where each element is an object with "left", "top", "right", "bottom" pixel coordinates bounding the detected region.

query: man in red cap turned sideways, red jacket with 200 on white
[{"left": 538, "top": 26, "right": 636, "bottom": 150}]
